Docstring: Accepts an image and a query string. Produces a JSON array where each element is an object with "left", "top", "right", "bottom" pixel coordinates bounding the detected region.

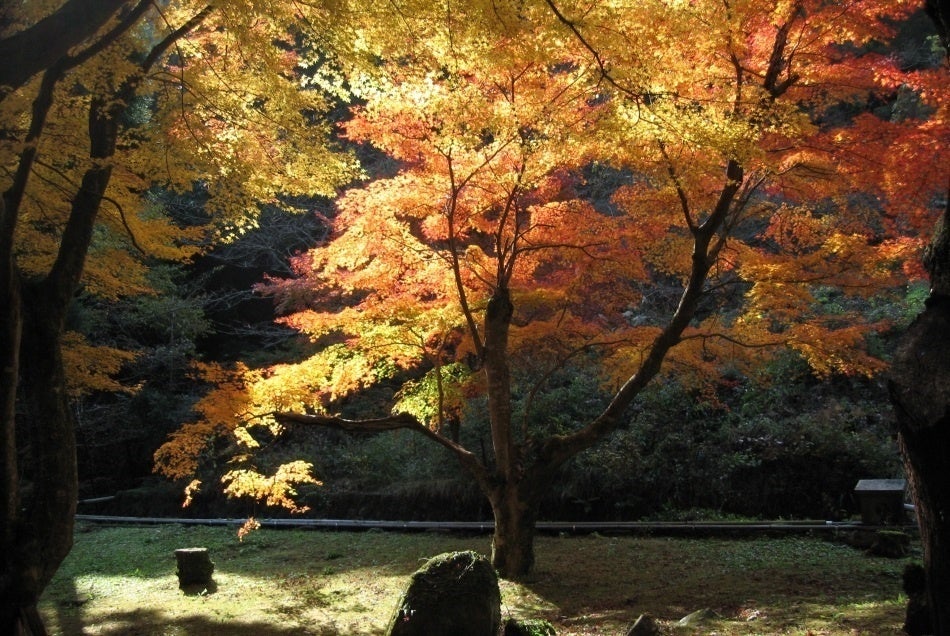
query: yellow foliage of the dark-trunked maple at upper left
[{"left": 0, "top": 0, "right": 358, "bottom": 306}]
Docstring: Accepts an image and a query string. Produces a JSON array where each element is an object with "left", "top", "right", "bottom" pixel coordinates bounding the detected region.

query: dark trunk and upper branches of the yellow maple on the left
[{"left": 0, "top": 7, "right": 201, "bottom": 635}]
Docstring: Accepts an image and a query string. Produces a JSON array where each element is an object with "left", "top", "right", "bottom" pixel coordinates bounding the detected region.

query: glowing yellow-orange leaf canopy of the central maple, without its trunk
[{"left": 242, "top": 0, "right": 932, "bottom": 428}]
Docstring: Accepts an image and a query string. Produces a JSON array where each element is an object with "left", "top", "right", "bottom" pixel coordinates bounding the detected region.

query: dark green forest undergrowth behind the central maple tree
[{"left": 74, "top": 221, "right": 927, "bottom": 520}]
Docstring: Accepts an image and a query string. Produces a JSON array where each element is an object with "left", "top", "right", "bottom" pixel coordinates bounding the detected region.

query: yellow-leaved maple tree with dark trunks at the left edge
[{"left": 0, "top": 0, "right": 351, "bottom": 634}]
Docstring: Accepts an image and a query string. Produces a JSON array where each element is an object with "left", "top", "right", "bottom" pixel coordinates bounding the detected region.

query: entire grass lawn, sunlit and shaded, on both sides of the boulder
[{"left": 40, "top": 526, "right": 906, "bottom": 636}]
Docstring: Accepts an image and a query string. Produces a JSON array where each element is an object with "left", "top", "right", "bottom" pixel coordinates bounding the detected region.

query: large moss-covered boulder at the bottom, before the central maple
[{"left": 386, "top": 550, "right": 501, "bottom": 636}]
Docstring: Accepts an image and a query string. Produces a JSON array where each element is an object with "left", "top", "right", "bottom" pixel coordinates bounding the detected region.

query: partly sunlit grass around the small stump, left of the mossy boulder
[{"left": 40, "top": 526, "right": 472, "bottom": 636}]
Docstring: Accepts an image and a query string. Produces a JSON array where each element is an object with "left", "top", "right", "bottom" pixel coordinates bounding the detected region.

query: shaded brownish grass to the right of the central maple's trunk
[{"left": 506, "top": 537, "right": 905, "bottom": 635}]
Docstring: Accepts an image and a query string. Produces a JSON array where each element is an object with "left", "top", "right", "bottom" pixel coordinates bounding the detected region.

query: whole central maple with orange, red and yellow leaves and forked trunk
[{"left": 156, "top": 0, "right": 946, "bottom": 576}]
